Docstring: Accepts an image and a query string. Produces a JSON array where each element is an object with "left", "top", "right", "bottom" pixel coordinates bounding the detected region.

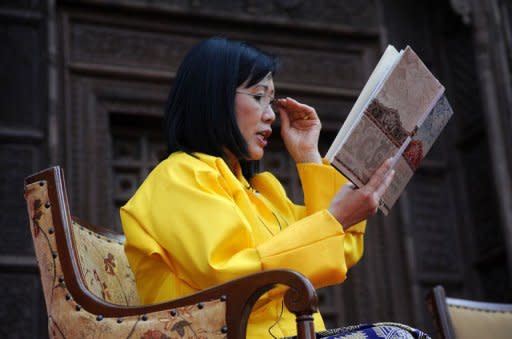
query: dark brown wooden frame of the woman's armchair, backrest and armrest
[{"left": 25, "top": 166, "right": 318, "bottom": 339}]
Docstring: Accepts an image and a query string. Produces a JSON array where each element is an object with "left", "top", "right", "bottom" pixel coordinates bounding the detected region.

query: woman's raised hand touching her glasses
[{"left": 277, "top": 98, "right": 322, "bottom": 163}]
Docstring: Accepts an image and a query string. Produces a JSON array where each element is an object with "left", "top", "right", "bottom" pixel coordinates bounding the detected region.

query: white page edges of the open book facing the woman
[{"left": 325, "top": 45, "right": 400, "bottom": 162}]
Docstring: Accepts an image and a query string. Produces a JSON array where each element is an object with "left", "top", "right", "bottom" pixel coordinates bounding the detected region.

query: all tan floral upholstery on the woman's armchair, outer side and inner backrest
[{"left": 25, "top": 181, "right": 226, "bottom": 339}]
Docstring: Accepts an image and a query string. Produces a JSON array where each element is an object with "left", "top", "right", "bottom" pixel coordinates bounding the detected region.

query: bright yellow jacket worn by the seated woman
[{"left": 121, "top": 152, "right": 365, "bottom": 338}]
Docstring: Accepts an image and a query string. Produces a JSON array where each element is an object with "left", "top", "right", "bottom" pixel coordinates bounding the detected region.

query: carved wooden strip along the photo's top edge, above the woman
[{"left": 64, "top": 0, "right": 379, "bottom": 32}]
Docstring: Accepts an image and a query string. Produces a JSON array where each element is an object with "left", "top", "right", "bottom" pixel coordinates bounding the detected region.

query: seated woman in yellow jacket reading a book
[{"left": 121, "top": 38, "right": 428, "bottom": 338}]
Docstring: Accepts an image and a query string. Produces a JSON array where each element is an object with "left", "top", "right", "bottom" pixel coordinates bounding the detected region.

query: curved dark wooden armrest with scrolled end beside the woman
[{"left": 77, "top": 270, "right": 318, "bottom": 338}]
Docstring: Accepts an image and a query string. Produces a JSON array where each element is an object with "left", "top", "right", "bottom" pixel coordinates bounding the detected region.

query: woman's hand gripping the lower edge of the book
[{"left": 329, "top": 158, "right": 395, "bottom": 230}]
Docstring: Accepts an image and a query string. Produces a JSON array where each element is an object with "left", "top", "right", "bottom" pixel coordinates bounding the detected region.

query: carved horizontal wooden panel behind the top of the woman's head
[{"left": 69, "top": 21, "right": 377, "bottom": 90}]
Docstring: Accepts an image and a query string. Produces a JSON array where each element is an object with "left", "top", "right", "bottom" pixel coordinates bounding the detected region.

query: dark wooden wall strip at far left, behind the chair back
[{"left": 0, "top": 0, "right": 48, "bottom": 338}]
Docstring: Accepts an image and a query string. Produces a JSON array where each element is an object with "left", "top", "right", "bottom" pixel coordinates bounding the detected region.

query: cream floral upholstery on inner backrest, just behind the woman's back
[{"left": 72, "top": 222, "right": 139, "bottom": 306}]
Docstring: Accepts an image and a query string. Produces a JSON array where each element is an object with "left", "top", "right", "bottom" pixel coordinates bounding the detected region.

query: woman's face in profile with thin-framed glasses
[{"left": 235, "top": 74, "right": 276, "bottom": 160}]
